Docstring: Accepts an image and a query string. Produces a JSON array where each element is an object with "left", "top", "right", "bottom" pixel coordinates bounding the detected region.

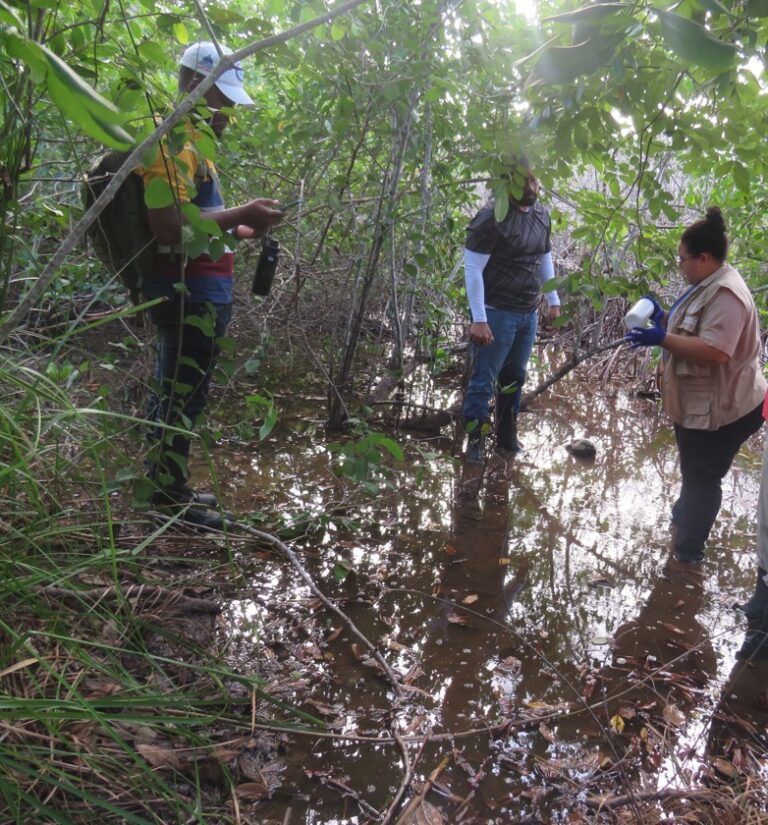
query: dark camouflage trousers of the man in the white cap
[{"left": 146, "top": 296, "right": 232, "bottom": 490}]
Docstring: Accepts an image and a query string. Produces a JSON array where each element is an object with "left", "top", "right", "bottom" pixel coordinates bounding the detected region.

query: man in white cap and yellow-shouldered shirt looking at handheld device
[{"left": 137, "top": 42, "right": 284, "bottom": 529}]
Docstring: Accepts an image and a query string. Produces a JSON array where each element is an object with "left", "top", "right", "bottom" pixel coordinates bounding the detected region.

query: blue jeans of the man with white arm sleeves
[{"left": 464, "top": 307, "right": 537, "bottom": 422}]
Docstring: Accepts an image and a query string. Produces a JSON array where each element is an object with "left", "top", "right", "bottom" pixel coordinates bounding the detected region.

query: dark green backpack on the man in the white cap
[{"left": 83, "top": 151, "right": 157, "bottom": 304}]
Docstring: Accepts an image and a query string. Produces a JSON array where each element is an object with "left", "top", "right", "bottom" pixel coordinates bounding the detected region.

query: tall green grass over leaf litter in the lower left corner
[{"left": 0, "top": 353, "right": 322, "bottom": 825}]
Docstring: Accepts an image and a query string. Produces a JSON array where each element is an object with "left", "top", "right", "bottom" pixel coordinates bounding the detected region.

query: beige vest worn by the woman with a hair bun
[{"left": 662, "top": 264, "right": 767, "bottom": 430}]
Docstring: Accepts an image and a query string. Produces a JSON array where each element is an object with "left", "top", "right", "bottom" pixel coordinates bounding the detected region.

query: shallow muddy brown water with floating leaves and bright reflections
[{"left": 194, "top": 382, "right": 768, "bottom": 823}]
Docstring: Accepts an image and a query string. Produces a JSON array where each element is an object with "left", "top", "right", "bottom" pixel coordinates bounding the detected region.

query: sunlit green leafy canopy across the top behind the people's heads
[{"left": 0, "top": 0, "right": 768, "bottom": 357}]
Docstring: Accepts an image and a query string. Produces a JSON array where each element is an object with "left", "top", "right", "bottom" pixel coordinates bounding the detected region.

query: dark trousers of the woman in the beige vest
[{"left": 672, "top": 403, "right": 763, "bottom": 562}]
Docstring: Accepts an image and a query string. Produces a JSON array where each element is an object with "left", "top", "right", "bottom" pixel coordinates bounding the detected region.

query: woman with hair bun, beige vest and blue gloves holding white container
[{"left": 626, "top": 207, "right": 766, "bottom": 564}]
